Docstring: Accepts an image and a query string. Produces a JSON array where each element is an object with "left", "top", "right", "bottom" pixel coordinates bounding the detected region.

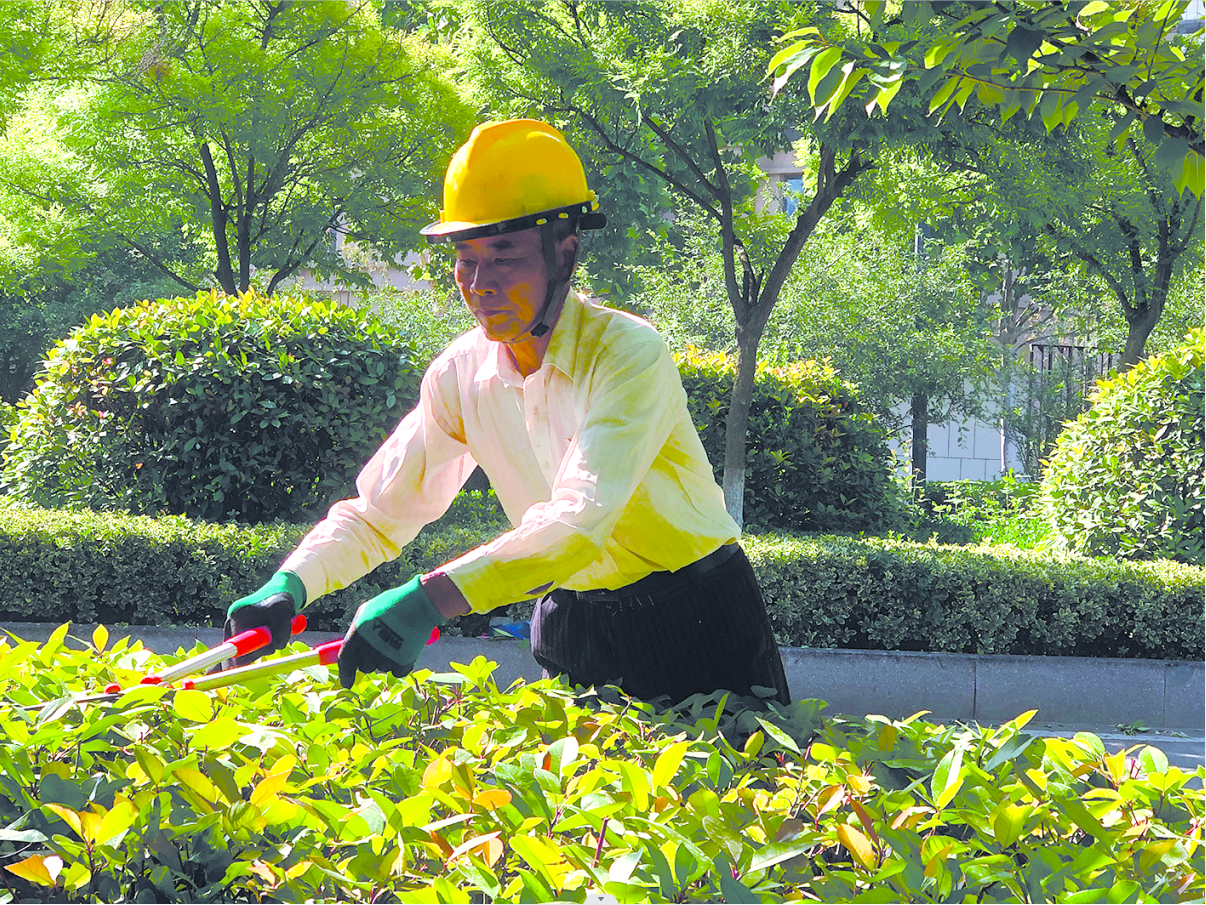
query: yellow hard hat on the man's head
[{"left": 421, "top": 119, "right": 607, "bottom": 243}]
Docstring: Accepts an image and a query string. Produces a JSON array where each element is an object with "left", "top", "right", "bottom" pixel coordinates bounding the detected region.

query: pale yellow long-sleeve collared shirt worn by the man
[{"left": 281, "top": 294, "right": 739, "bottom": 612}]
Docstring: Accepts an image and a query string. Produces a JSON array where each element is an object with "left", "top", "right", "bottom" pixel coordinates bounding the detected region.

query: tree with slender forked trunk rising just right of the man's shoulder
[{"left": 461, "top": 0, "right": 935, "bottom": 524}]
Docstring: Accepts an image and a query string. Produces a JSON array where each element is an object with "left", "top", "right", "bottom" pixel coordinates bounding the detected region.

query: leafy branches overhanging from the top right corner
[{"left": 769, "top": 0, "right": 1206, "bottom": 197}]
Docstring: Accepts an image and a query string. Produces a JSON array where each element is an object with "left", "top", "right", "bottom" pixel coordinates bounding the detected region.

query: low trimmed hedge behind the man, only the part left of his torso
[{"left": 0, "top": 495, "right": 509, "bottom": 631}]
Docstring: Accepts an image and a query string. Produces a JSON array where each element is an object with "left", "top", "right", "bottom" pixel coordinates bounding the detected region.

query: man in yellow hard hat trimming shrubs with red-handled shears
[{"left": 227, "top": 119, "right": 789, "bottom": 703}]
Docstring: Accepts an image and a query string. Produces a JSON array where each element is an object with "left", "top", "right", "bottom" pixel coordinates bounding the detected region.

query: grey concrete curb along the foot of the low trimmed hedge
[{"left": 0, "top": 623, "right": 1206, "bottom": 736}]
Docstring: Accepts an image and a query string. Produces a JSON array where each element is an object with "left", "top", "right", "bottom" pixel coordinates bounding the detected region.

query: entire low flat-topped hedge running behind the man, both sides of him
[{"left": 0, "top": 504, "right": 1204, "bottom": 660}]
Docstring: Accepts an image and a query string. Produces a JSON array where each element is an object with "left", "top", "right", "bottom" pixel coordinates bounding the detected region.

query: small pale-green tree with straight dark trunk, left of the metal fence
[{"left": 767, "top": 224, "right": 1001, "bottom": 484}]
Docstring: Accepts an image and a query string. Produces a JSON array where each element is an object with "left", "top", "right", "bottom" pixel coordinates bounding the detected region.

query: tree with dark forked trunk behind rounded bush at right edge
[{"left": 948, "top": 117, "right": 1202, "bottom": 366}]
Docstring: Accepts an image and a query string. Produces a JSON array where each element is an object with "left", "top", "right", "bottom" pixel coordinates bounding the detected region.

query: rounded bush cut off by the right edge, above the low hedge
[{"left": 1042, "top": 329, "right": 1206, "bottom": 562}]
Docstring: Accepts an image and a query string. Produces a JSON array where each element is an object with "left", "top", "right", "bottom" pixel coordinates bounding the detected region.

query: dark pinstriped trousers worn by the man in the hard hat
[{"left": 532, "top": 544, "right": 791, "bottom": 703}]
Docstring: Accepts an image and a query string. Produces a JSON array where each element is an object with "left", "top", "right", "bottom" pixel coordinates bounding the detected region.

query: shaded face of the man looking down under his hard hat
[{"left": 456, "top": 228, "right": 549, "bottom": 343}]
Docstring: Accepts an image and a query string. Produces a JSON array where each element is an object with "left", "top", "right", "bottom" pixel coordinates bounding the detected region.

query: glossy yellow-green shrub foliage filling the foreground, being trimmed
[{"left": 0, "top": 626, "right": 1202, "bottom": 903}]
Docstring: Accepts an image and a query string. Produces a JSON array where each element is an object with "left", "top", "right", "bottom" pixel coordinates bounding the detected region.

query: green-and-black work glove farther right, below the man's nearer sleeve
[{"left": 339, "top": 576, "right": 445, "bottom": 688}]
